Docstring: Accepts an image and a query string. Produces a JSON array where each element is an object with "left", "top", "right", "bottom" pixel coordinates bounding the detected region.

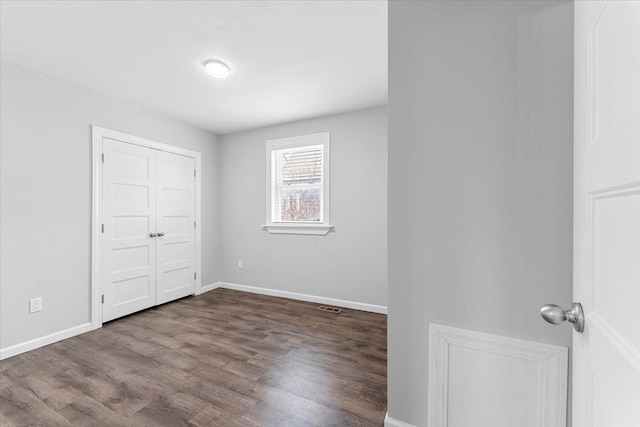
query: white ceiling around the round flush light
[{"left": 0, "top": 0, "right": 387, "bottom": 134}]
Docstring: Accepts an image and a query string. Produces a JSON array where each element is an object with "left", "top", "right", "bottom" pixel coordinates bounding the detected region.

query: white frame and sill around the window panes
[{"left": 263, "top": 132, "right": 333, "bottom": 235}]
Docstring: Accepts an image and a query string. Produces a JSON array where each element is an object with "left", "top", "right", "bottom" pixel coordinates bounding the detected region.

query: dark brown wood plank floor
[{"left": 0, "top": 289, "right": 387, "bottom": 427}]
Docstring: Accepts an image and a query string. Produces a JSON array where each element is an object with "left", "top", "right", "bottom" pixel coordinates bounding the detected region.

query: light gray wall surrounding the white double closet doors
[{"left": 0, "top": 61, "right": 221, "bottom": 349}]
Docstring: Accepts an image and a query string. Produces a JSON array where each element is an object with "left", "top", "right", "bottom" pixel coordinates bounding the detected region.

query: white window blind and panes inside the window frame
[{"left": 271, "top": 144, "right": 324, "bottom": 223}]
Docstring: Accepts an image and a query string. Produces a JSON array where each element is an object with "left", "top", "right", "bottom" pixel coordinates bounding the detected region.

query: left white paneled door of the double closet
[{"left": 102, "top": 138, "right": 157, "bottom": 322}]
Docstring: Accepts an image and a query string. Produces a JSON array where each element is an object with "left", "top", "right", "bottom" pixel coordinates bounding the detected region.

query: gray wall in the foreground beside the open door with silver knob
[{"left": 388, "top": 1, "right": 573, "bottom": 426}]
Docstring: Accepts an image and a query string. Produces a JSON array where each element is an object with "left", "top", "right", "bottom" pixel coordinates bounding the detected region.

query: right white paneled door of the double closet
[{"left": 156, "top": 151, "right": 195, "bottom": 304}]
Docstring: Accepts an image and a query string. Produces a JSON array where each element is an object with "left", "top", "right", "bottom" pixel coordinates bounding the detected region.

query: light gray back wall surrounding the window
[{"left": 220, "top": 107, "right": 387, "bottom": 306}]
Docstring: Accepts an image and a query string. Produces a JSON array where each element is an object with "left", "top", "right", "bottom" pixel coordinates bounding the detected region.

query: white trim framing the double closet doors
[{"left": 91, "top": 126, "right": 202, "bottom": 329}]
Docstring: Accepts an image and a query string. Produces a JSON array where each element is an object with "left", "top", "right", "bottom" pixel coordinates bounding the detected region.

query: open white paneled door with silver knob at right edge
[{"left": 573, "top": 0, "right": 640, "bottom": 427}]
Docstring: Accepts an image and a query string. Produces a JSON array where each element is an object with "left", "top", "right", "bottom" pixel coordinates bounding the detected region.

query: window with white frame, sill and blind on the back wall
[{"left": 265, "top": 132, "right": 331, "bottom": 234}]
